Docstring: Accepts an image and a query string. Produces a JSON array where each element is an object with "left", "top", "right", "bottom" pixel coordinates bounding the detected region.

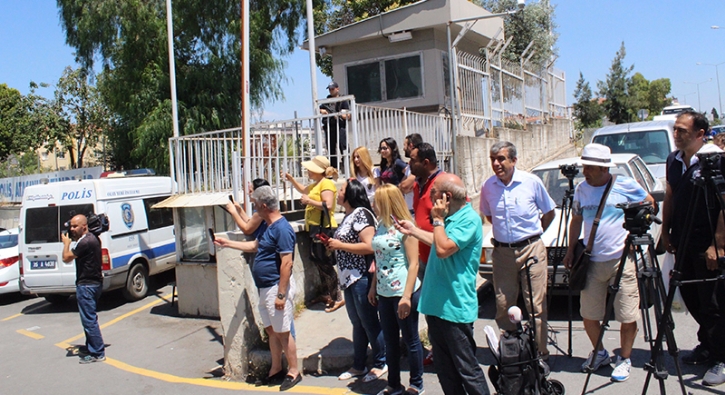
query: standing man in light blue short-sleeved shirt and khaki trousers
[{"left": 480, "top": 141, "right": 556, "bottom": 358}]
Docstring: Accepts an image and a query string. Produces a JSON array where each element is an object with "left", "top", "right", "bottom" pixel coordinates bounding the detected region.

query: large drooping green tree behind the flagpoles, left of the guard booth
[{"left": 58, "top": 0, "right": 305, "bottom": 174}]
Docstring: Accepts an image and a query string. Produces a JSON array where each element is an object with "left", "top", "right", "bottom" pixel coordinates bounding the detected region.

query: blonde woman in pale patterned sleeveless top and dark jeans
[{"left": 368, "top": 184, "right": 423, "bottom": 395}]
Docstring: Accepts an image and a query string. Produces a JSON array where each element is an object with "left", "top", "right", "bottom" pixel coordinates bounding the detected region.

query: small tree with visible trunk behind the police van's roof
[{"left": 50, "top": 67, "right": 111, "bottom": 169}]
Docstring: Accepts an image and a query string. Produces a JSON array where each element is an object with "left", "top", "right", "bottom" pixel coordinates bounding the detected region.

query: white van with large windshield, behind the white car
[{"left": 591, "top": 121, "right": 675, "bottom": 179}]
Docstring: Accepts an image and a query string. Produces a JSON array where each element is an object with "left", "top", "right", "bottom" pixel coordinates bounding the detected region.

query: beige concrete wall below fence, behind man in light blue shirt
[{"left": 455, "top": 119, "right": 577, "bottom": 195}]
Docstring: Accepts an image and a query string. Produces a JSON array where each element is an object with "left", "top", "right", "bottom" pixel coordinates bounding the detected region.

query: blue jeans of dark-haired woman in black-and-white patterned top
[{"left": 345, "top": 275, "right": 385, "bottom": 370}]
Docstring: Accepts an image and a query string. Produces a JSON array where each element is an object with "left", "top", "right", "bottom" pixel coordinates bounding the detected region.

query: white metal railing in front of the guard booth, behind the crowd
[{"left": 169, "top": 102, "right": 453, "bottom": 211}]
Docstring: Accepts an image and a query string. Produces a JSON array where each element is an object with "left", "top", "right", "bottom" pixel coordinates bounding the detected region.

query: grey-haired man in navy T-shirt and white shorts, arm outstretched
[{"left": 214, "top": 186, "right": 302, "bottom": 391}]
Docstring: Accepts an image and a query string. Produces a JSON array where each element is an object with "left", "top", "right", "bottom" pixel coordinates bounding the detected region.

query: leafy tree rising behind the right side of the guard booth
[{"left": 473, "top": 0, "right": 559, "bottom": 67}]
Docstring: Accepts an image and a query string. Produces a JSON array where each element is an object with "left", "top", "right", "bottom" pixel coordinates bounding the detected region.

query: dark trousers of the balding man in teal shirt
[{"left": 425, "top": 315, "right": 490, "bottom": 395}]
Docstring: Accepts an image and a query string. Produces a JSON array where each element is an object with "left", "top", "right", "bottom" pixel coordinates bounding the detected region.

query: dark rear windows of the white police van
[{"left": 25, "top": 204, "right": 94, "bottom": 244}]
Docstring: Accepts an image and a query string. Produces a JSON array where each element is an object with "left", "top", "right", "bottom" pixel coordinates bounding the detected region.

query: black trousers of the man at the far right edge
[{"left": 680, "top": 251, "right": 725, "bottom": 362}]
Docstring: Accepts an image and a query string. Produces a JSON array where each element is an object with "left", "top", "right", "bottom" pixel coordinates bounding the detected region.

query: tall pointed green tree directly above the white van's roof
[{"left": 597, "top": 41, "right": 634, "bottom": 123}]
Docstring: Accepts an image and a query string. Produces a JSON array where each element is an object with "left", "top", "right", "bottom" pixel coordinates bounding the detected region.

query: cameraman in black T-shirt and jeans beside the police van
[{"left": 62, "top": 214, "right": 106, "bottom": 364}]
